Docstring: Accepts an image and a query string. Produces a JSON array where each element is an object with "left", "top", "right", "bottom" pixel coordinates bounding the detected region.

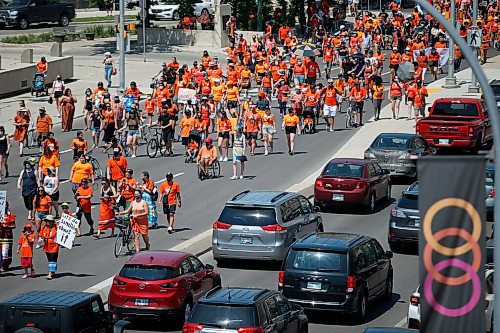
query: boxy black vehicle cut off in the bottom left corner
[{"left": 0, "top": 290, "right": 124, "bottom": 333}]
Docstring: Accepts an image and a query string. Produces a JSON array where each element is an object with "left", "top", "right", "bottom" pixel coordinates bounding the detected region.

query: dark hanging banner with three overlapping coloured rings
[{"left": 417, "top": 156, "right": 486, "bottom": 333}]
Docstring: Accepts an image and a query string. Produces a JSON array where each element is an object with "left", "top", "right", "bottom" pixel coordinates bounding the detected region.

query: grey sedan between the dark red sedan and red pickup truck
[{"left": 365, "top": 133, "right": 433, "bottom": 177}]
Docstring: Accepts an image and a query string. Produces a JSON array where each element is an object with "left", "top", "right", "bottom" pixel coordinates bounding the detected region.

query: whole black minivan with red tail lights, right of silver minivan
[{"left": 278, "top": 232, "right": 393, "bottom": 322}]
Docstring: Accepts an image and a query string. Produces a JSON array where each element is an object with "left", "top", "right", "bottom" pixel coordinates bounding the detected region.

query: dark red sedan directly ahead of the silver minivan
[{"left": 314, "top": 158, "right": 391, "bottom": 211}]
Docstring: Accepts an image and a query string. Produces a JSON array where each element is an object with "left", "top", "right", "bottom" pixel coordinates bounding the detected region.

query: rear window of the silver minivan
[{"left": 219, "top": 206, "right": 276, "bottom": 227}]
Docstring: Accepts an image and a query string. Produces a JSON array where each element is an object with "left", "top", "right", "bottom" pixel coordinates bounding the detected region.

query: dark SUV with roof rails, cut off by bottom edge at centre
[{"left": 182, "top": 287, "right": 308, "bottom": 333}]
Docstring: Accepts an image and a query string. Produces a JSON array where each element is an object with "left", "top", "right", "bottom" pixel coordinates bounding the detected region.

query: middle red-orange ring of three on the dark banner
[{"left": 424, "top": 228, "right": 482, "bottom": 286}]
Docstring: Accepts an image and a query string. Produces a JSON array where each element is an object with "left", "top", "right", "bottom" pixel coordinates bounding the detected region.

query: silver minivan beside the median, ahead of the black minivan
[{"left": 212, "top": 190, "right": 323, "bottom": 262}]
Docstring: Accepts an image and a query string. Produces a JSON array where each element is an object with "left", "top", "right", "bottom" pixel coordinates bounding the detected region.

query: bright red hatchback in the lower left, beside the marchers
[{"left": 108, "top": 251, "right": 221, "bottom": 325}]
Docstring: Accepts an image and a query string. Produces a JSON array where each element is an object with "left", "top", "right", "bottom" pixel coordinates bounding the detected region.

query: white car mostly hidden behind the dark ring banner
[{"left": 407, "top": 268, "right": 495, "bottom": 332}]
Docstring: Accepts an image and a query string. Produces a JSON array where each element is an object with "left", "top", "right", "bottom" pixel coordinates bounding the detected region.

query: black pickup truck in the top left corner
[{"left": 0, "top": 0, "right": 75, "bottom": 29}]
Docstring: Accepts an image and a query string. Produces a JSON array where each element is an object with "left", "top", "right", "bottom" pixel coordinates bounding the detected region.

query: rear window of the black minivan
[{"left": 286, "top": 250, "right": 347, "bottom": 273}]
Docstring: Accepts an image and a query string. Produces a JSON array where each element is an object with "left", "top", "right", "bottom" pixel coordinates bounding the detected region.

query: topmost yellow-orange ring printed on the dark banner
[{"left": 423, "top": 198, "right": 482, "bottom": 256}]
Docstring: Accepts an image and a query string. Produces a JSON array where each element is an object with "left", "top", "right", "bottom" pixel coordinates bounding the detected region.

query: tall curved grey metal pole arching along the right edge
[{"left": 415, "top": 0, "right": 500, "bottom": 333}]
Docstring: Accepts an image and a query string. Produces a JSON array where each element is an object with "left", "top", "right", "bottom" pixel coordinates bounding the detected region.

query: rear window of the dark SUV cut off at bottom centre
[{"left": 189, "top": 303, "right": 257, "bottom": 330}]
